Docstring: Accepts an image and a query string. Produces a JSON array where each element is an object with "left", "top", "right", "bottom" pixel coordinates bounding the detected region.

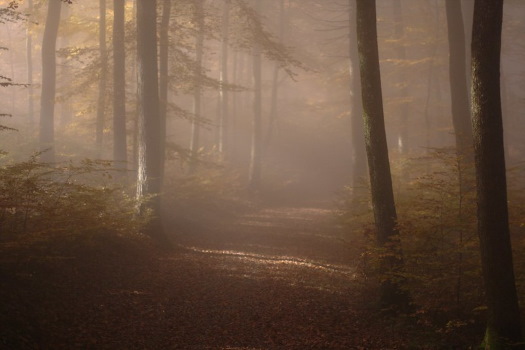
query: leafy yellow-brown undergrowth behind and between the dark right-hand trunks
[{"left": 338, "top": 149, "right": 525, "bottom": 340}]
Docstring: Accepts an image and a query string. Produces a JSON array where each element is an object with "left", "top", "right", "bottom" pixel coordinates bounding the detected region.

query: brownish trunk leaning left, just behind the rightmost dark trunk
[{"left": 445, "top": 0, "right": 474, "bottom": 196}]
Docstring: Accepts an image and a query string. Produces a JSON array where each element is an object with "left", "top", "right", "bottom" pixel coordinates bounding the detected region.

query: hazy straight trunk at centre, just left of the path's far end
[{"left": 248, "top": 0, "right": 262, "bottom": 190}]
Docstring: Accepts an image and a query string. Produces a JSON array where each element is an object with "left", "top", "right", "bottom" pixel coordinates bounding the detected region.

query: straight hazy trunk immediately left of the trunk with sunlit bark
[{"left": 113, "top": 0, "right": 128, "bottom": 169}]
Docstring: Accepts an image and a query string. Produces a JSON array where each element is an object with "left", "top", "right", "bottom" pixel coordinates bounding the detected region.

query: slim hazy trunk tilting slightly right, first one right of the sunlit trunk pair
[{"left": 189, "top": 0, "right": 204, "bottom": 173}]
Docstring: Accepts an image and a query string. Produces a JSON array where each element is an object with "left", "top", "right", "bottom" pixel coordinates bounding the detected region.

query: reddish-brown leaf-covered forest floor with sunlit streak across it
[{"left": 0, "top": 198, "right": 474, "bottom": 350}]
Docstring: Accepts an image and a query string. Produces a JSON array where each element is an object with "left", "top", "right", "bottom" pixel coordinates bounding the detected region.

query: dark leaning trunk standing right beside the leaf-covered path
[{"left": 356, "top": 0, "right": 408, "bottom": 307}]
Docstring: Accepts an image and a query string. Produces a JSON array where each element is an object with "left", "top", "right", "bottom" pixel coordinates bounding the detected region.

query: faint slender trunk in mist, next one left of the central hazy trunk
[{"left": 219, "top": 0, "right": 230, "bottom": 157}]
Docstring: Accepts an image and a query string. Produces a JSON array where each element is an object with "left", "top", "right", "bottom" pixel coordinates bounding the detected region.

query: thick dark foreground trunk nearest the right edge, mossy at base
[{"left": 472, "top": 0, "right": 523, "bottom": 349}]
